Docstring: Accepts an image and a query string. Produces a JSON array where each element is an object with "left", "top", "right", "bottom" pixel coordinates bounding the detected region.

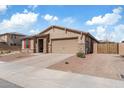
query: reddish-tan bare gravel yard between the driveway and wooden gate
[{"left": 48, "top": 54, "right": 124, "bottom": 80}]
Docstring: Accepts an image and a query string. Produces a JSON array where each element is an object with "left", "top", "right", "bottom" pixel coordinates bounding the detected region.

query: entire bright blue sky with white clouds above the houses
[{"left": 0, "top": 5, "right": 124, "bottom": 41}]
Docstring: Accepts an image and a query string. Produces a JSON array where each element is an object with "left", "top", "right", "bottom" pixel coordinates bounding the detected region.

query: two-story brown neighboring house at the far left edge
[{"left": 0, "top": 32, "right": 25, "bottom": 46}]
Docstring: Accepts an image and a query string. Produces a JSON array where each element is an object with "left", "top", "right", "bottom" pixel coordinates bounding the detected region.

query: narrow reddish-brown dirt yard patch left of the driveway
[{"left": 0, "top": 53, "right": 33, "bottom": 62}]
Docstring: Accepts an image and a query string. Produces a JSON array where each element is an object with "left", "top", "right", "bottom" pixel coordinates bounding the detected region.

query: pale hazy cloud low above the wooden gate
[{"left": 89, "top": 24, "right": 124, "bottom": 42}]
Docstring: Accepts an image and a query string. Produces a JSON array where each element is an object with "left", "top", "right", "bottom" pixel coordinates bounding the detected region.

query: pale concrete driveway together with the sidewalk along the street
[{"left": 0, "top": 54, "right": 124, "bottom": 88}]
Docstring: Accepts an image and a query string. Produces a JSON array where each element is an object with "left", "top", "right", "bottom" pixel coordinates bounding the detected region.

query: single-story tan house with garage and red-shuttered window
[{"left": 22, "top": 26, "right": 98, "bottom": 54}]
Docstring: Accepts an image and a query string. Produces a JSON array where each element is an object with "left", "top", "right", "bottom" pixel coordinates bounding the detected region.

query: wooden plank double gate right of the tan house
[{"left": 97, "top": 43, "right": 118, "bottom": 54}]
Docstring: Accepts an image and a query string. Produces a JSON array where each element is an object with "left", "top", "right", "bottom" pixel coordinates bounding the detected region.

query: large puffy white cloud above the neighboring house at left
[{"left": 0, "top": 12, "right": 39, "bottom": 33}]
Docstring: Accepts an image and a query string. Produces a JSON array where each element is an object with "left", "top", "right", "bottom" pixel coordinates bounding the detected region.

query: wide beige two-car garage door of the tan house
[{"left": 52, "top": 38, "right": 78, "bottom": 53}]
